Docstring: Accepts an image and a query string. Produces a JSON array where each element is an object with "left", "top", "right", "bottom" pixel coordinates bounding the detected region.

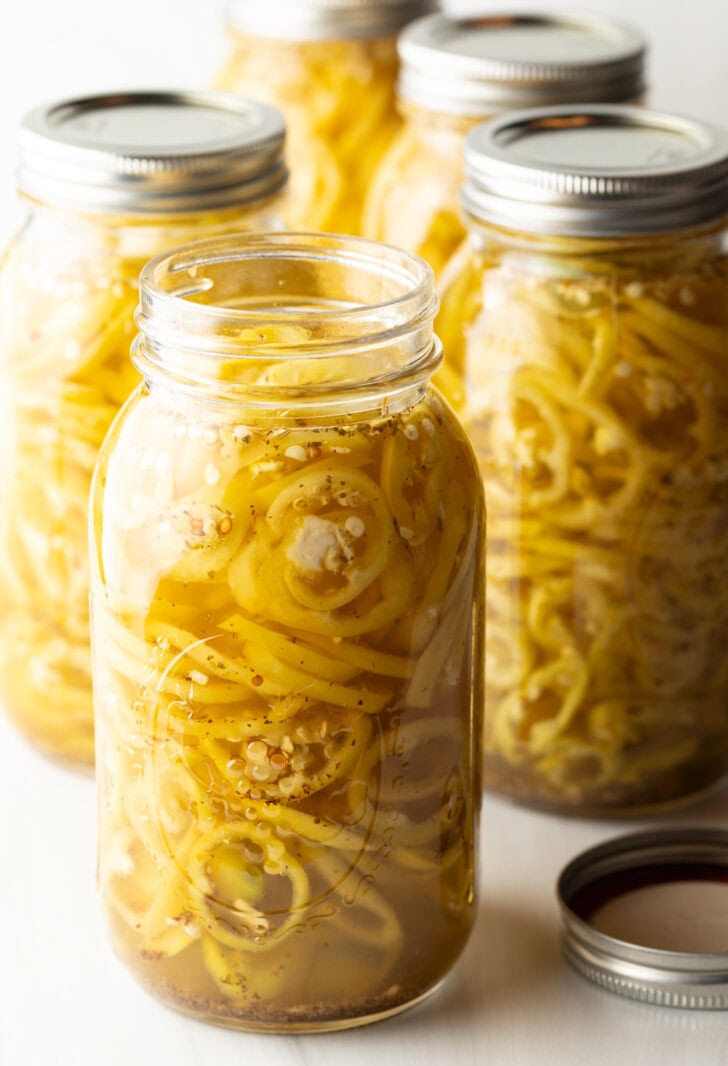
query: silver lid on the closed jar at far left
[{"left": 18, "top": 92, "right": 287, "bottom": 215}]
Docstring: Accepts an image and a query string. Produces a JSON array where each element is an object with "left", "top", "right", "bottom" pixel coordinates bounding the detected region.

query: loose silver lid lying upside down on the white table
[{"left": 557, "top": 827, "right": 728, "bottom": 1011}]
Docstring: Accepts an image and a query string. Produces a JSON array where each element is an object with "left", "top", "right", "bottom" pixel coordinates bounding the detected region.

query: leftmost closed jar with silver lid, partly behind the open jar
[{"left": 0, "top": 93, "right": 286, "bottom": 763}]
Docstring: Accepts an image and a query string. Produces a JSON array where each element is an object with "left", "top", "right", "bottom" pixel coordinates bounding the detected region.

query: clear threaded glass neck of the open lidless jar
[{"left": 134, "top": 233, "right": 441, "bottom": 419}]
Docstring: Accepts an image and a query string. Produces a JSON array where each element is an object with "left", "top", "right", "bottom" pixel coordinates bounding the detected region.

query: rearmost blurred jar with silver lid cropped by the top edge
[{"left": 217, "top": 0, "right": 435, "bottom": 233}]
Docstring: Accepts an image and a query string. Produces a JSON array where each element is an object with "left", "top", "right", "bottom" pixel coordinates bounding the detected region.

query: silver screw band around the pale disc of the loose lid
[{"left": 557, "top": 827, "right": 728, "bottom": 1011}]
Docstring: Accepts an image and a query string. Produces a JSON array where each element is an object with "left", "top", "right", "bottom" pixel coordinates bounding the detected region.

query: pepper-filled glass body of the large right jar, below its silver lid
[{"left": 438, "top": 244, "right": 728, "bottom": 811}]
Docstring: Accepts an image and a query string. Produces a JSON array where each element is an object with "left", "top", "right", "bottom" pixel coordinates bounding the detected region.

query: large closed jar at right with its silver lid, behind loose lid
[{"left": 436, "top": 107, "right": 728, "bottom": 813}]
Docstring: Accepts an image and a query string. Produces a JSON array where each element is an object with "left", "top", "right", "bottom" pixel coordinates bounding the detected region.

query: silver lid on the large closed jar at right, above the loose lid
[{"left": 463, "top": 104, "right": 728, "bottom": 237}]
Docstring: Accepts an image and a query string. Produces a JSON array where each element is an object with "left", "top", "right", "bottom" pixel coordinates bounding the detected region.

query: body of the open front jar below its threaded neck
[{"left": 94, "top": 397, "right": 483, "bottom": 1029}]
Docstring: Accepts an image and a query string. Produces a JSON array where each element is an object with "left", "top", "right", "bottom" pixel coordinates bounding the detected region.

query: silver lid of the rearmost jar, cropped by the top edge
[{"left": 227, "top": 0, "right": 438, "bottom": 41}]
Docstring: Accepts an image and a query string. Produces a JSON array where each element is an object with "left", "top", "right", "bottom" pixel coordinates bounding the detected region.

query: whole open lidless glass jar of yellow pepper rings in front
[{"left": 92, "top": 235, "right": 484, "bottom": 1031}]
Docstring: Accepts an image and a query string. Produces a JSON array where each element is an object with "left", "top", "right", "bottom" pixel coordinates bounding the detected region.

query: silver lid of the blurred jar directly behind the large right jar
[{"left": 399, "top": 14, "right": 645, "bottom": 117}]
